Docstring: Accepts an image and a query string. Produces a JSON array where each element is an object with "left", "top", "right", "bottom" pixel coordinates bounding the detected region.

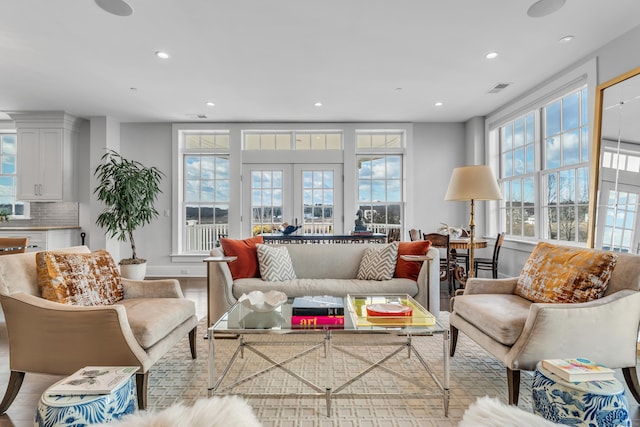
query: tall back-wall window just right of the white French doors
[{"left": 356, "top": 130, "right": 404, "bottom": 233}]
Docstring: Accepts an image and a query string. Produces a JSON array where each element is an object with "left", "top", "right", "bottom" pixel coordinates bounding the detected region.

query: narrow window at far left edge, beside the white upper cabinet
[{"left": 0, "top": 132, "right": 26, "bottom": 217}]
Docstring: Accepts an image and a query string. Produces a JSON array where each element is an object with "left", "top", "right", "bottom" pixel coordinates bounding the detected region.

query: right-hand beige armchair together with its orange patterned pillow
[{"left": 449, "top": 243, "right": 640, "bottom": 404}]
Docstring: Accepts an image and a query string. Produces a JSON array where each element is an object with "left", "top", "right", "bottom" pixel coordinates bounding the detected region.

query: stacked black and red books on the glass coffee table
[{"left": 291, "top": 296, "right": 344, "bottom": 329}]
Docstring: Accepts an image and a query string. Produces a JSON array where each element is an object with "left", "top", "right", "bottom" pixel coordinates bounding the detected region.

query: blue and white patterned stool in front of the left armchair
[{"left": 34, "top": 375, "right": 138, "bottom": 427}]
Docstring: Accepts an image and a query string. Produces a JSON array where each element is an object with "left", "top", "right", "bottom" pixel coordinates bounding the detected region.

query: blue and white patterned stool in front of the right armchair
[{"left": 532, "top": 363, "right": 631, "bottom": 427}]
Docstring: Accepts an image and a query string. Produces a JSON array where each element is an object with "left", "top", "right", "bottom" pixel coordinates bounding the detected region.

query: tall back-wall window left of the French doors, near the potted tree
[{"left": 182, "top": 133, "right": 230, "bottom": 253}]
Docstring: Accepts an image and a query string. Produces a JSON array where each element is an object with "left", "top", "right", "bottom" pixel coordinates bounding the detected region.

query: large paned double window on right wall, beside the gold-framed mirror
[{"left": 498, "top": 87, "right": 590, "bottom": 243}]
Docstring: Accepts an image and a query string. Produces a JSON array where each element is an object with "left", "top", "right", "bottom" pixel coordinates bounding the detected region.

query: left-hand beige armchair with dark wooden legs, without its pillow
[{"left": 0, "top": 246, "right": 198, "bottom": 414}]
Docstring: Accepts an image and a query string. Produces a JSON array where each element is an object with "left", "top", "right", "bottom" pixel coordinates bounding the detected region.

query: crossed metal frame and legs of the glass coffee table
[{"left": 207, "top": 299, "right": 449, "bottom": 417}]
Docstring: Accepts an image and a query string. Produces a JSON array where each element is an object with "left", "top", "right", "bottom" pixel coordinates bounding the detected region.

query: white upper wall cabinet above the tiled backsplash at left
[{"left": 11, "top": 112, "right": 78, "bottom": 202}]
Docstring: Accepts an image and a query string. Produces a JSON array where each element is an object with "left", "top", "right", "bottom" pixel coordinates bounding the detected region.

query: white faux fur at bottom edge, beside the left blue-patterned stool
[{"left": 98, "top": 396, "right": 262, "bottom": 427}]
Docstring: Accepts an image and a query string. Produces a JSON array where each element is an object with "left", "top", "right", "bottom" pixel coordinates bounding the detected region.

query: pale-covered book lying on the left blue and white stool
[{"left": 47, "top": 366, "right": 139, "bottom": 395}]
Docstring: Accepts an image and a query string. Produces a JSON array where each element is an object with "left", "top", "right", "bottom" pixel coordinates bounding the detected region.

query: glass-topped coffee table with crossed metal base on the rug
[{"left": 207, "top": 294, "right": 449, "bottom": 416}]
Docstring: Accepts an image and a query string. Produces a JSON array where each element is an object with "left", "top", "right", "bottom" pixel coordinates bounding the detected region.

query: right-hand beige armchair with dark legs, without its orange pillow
[{"left": 450, "top": 247, "right": 640, "bottom": 405}]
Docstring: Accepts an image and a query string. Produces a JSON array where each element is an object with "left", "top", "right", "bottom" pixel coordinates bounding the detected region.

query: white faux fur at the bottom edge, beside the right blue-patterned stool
[{"left": 458, "top": 396, "right": 558, "bottom": 427}]
